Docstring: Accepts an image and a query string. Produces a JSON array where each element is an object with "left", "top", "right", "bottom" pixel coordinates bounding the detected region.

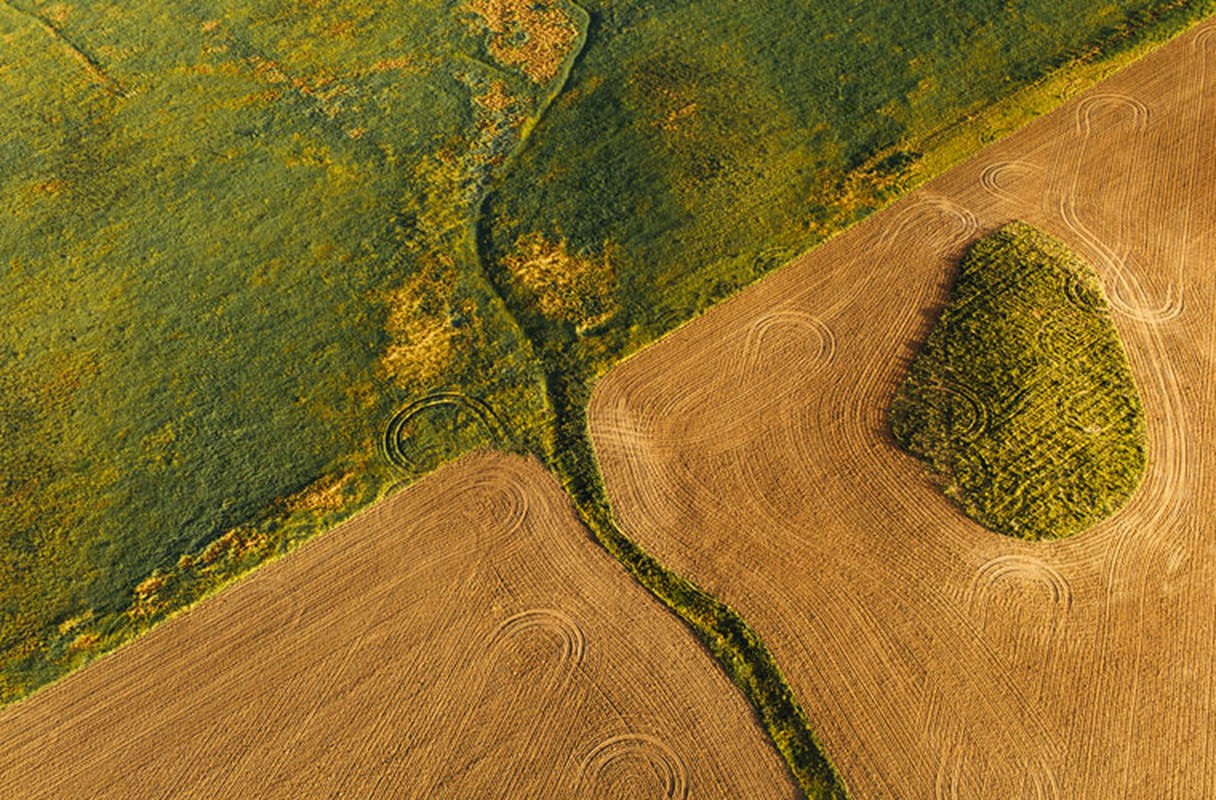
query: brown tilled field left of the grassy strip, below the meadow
[{"left": 0, "top": 455, "right": 794, "bottom": 800}]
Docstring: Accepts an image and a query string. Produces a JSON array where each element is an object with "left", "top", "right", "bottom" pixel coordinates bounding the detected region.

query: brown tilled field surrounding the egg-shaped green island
[{"left": 591, "top": 21, "right": 1216, "bottom": 800}]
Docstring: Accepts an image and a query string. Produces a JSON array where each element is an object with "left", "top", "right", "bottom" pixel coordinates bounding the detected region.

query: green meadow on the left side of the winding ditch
[{"left": 0, "top": 0, "right": 547, "bottom": 699}]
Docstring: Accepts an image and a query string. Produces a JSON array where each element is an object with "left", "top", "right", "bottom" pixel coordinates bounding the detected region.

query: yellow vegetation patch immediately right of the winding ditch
[{"left": 503, "top": 233, "right": 617, "bottom": 331}]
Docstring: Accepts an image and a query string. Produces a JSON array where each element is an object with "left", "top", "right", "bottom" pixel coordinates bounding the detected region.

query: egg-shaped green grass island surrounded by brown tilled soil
[{"left": 890, "top": 222, "right": 1145, "bottom": 539}]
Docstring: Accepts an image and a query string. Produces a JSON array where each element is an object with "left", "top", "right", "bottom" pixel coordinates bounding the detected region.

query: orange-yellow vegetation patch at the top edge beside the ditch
[{"left": 466, "top": 0, "right": 579, "bottom": 84}]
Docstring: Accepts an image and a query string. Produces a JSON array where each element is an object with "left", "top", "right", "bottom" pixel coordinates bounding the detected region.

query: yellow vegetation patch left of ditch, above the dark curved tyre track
[{"left": 381, "top": 269, "right": 458, "bottom": 387}]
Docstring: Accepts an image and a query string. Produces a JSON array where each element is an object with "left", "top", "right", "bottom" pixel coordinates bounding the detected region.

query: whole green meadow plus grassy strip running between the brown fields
[{"left": 0, "top": 0, "right": 1216, "bottom": 796}]
